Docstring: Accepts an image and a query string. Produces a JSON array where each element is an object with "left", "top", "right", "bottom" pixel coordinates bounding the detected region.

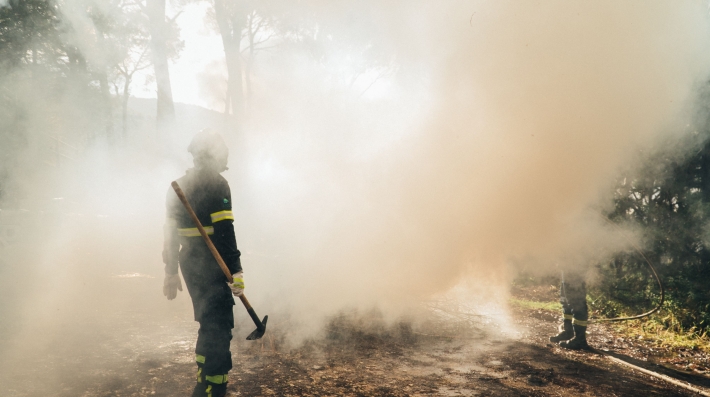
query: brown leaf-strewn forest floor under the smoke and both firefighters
[{"left": 0, "top": 278, "right": 710, "bottom": 397}]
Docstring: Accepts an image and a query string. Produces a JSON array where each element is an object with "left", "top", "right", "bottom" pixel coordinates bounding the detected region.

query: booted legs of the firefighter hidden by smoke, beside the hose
[{"left": 550, "top": 271, "right": 590, "bottom": 350}]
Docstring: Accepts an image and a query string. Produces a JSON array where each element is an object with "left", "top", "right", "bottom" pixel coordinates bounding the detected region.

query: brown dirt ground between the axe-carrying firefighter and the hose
[{"left": 220, "top": 311, "right": 704, "bottom": 396}]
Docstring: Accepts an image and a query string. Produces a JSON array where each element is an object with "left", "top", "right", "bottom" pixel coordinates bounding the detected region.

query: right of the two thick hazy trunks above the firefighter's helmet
[{"left": 214, "top": 0, "right": 247, "bottom": 131}]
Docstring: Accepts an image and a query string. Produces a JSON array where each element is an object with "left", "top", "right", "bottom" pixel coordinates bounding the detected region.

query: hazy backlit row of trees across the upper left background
[{"left": 0, "top": 0, "right": 392, "bottom": 200}]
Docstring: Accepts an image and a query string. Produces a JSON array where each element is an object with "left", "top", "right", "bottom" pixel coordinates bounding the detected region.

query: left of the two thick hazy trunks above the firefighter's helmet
[{"left": 147, "top": 0, "right": 175, "bottom": 125}]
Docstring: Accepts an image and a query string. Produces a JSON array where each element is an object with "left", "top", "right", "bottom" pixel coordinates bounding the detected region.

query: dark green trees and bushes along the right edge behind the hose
[{"left": 597, "top": 86, "right": 710, "bottom": 332}]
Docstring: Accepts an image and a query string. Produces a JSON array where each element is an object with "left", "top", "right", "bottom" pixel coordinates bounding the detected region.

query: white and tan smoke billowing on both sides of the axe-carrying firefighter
[{"left": 0, "top": 0, "right": 710, "bottom": 390}]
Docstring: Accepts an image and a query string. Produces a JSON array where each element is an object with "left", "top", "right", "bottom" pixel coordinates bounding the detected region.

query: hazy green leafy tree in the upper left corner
[{"left": 0, "top": 0, "right": 111, "bottom": 199}]
